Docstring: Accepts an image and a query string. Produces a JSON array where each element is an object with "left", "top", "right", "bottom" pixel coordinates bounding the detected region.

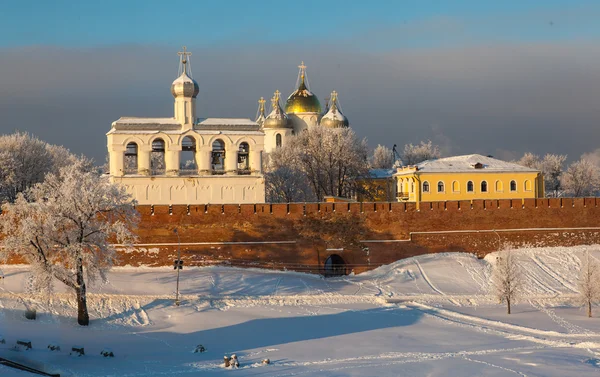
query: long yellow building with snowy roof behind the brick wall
[{"left": 394, "top": 154, "right": 544, "bottom": 203}]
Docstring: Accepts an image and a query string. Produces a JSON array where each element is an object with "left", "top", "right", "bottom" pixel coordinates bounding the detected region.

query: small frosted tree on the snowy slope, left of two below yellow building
[{"left": 490, "top": 247, "right": 522, "bottom": 314}]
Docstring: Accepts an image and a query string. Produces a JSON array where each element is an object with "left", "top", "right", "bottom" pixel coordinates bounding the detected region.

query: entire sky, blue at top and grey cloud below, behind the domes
[{"left": 0, "top": 0, "right": 600, "bottom": 162}]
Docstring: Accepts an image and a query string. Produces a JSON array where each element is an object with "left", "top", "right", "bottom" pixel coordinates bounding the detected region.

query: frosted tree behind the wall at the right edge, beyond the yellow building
[{"left": 560, "top": 158, "right": 600, "bottom": 197}]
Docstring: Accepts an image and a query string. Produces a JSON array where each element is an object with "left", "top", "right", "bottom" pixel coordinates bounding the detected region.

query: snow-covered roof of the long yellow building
[{"left": 397, "top": 154, "right": 539, "bottom": 174}]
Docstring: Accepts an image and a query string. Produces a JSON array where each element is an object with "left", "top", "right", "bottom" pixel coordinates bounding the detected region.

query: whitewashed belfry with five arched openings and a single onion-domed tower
[{"left": 107, "top": 51, "right": 265, "bottom": 205}]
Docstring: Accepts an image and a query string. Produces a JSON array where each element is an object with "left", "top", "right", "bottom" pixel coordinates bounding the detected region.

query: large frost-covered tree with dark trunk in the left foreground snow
[{"left": 0, "top": 160, "right": 138, "bottom": 325}]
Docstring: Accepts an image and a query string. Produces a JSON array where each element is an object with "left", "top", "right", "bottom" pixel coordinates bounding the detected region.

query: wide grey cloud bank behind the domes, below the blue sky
[{"left": 0, "top": 42, "right": 600, "bottom": 161}]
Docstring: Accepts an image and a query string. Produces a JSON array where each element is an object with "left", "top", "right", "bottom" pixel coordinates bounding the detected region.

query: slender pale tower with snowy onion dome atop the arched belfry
[{"left": 171, "top": 46, "right": 200, "bottom": 129}]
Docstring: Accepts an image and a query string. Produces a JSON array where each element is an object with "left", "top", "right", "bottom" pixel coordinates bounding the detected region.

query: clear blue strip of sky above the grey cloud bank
[{"left": 0, "top": 0, "right": 600, "bottom": 50}]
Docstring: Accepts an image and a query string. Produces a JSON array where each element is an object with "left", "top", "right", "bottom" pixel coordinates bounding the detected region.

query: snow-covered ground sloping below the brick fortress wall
[{"left": 0, "top": 246, "right": 600, "bottom": 377}]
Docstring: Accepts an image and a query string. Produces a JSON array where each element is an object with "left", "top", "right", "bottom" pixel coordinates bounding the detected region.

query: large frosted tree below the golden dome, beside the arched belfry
[{"left": 266, "top": 127, "right": 369, "bottom": 201}]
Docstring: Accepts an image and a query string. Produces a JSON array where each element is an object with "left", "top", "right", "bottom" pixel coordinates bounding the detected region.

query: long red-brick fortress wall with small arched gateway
[{"left": 110, "top": 198, "right": 600, "bottom": 273}]
